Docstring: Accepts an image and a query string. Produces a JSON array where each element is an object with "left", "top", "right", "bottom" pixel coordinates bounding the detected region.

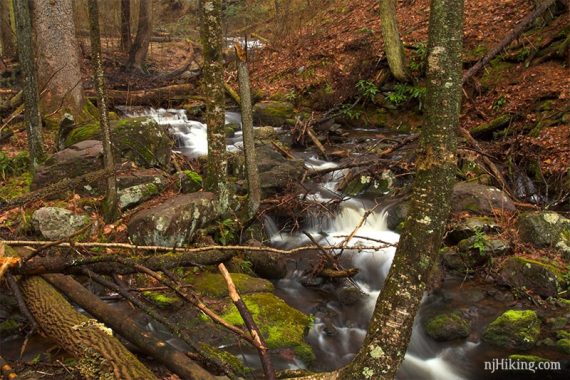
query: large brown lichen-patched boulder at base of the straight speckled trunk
[{"left": 128, "top": 192, "right": 219, "bottom": 247}]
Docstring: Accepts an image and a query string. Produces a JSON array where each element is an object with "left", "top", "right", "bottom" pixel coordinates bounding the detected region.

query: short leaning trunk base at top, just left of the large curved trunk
[{"left": 380, "top": 0, "right": 408, "bottom": 81}]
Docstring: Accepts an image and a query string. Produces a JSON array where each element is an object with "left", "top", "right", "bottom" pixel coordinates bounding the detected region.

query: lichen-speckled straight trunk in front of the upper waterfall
[{"left": 200, "top": 0, "right": 229, "bottom": 213}]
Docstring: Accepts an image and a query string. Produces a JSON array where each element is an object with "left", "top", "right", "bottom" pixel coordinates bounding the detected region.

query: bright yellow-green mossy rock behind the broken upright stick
[{"left": 222, "top": 293, "right": 315, "bottom": 364}]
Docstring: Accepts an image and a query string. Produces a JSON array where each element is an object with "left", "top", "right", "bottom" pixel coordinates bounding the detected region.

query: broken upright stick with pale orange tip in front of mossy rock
[{"left": 218, "top": 263, "right": 277, "bottom": 380}]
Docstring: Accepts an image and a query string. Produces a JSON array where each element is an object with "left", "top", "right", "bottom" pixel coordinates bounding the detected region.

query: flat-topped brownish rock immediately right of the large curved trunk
[{"left": 451, "top": 182, "right": 516, "bottom": 215}]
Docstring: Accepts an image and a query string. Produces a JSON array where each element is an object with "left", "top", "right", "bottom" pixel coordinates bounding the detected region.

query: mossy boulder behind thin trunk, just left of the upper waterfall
[{"left": 64, "top": 117, "right": 173, "bottom": 168}]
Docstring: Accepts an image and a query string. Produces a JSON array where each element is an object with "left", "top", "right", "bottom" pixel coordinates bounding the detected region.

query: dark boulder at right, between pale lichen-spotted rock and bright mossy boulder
[{"left": 500, "top": 256, "right": 562, "bottom": 297}]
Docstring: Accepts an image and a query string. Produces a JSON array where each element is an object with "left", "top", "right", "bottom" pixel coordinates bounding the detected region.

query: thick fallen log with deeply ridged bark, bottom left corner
[{"left": 20, "top": 277, "right": 156, "bottom": 380}]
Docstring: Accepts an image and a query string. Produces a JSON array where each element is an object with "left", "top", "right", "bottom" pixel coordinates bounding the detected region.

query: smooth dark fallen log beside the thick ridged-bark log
[{"left": 44, "top": 274, "right": 214, "bottom": 380}]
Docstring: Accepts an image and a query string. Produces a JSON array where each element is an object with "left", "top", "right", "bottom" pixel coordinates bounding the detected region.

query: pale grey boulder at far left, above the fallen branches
[{"left": 32, "top": 207, "right": 89, "bottom": 240}]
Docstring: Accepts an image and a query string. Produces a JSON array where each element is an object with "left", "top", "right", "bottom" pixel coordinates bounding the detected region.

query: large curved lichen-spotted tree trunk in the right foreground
[{"left": 342, "top": 0, "right": 463, "bottom": 379}]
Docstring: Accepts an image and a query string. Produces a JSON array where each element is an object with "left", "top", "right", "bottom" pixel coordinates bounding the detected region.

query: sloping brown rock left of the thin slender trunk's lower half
[{"left": 30, "top": 140, "right": 103, "bottom": 190}]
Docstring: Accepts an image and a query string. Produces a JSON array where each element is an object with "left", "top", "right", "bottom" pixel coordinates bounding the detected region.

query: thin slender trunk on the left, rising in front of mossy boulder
[{"left": 87, "top": 0, "right": 119, "bottom": 223}]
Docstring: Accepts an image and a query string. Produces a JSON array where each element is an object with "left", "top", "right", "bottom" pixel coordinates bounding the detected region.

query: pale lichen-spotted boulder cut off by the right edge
[{"left": 517, "top": 211, "right": 570, "bottom": 248}]
